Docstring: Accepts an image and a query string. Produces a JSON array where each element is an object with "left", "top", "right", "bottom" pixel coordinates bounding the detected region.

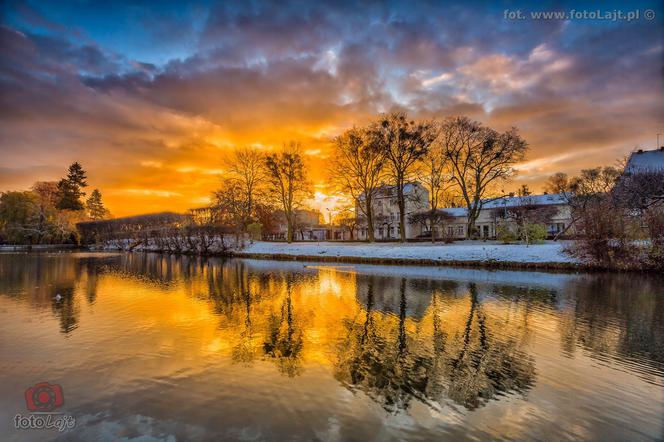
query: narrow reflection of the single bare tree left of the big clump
[{"left": 263, "top": 277, "right": 304, "bottom": 377}]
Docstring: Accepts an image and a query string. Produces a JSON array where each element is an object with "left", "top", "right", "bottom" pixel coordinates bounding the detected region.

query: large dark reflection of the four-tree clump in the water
[{"left": 335, "top": 278, "right": 535, "bottom": 411}]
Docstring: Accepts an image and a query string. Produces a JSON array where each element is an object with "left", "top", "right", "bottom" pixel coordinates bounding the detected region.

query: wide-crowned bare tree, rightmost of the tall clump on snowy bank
[{"left": 439, "top": 117, "right": 528, "bottom": 236}]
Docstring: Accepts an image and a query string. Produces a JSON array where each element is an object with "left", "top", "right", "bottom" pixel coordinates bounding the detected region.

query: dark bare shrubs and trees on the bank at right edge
[{"left": 546, "top": 167, "right": 664, "bottom": 269}]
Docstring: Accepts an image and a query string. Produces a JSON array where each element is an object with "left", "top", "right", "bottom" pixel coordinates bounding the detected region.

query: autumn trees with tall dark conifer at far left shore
[{"left": 0, "top": 163, "right": 110, "bottom": 244}]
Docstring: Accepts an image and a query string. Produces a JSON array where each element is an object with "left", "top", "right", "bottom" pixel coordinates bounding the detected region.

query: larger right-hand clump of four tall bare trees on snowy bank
[{"left": 330, "top": 112, "right": 528, "bottom": 242}]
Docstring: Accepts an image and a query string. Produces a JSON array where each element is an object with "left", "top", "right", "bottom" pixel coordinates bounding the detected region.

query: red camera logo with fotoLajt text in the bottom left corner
[{"left": 14, "top": 382, "right": 76, "bottom": 431}]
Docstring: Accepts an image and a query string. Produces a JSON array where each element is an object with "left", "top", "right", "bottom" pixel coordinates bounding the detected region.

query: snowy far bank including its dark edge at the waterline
[{"left": 231, "top": 241, "right": 588, "bottom": 270}]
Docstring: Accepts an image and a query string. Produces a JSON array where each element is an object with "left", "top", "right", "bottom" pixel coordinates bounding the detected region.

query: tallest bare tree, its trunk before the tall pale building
[{"left": 371, "top": 112, "right": 435, "bottom": 242}]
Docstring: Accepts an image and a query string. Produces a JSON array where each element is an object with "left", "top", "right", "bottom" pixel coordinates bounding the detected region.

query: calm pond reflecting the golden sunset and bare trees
[{"left": 0, "top": 252, "right": 664, "bottom": 441}]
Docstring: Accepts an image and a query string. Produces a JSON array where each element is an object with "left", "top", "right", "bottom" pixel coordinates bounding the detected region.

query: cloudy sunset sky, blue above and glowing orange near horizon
[{"left": 0, "top": 0, "right": 664, "bottom": 216}]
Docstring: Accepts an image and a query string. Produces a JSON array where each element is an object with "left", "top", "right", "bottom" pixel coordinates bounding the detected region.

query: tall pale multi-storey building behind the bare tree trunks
[{"left": 355, "top": 182, "right": 429, "bottom": 240}]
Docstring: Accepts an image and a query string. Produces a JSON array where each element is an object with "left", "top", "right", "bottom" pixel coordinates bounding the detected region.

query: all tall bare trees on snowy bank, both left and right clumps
[{"left": 213, "top": 112, "right": 527, "bottom": 242}]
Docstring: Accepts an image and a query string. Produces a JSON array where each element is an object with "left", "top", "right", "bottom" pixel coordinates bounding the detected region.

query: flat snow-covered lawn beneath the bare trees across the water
[{"left": 237, "top": 241, "right": 577, "bottom": 263}]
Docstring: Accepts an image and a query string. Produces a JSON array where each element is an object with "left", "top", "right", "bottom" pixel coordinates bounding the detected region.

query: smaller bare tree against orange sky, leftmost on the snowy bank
[{"left": 225, "top": 147, "right": 266, "bottom": 231}]
